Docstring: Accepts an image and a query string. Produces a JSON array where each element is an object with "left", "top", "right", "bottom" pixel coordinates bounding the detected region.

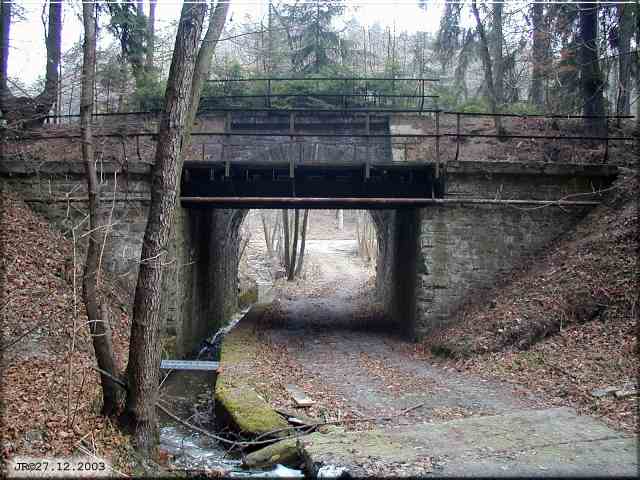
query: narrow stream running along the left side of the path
[{"left": 160, "top": 308, "right": 304, "bottom": 478}]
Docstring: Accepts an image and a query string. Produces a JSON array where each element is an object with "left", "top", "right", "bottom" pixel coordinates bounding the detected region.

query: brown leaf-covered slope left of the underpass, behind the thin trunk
[{"left": 0, "top": 189, "right": 129, "bottom": 468}]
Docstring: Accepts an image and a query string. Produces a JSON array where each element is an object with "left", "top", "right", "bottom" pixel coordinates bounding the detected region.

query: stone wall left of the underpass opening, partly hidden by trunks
[{"left": 0, "top": 158, "right": 244, "bottom": 355}]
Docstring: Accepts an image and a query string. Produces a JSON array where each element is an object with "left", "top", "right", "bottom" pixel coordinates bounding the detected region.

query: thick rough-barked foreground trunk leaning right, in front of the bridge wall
[{"left": 124, "top": 2, "right": 207, "bottom": 455}]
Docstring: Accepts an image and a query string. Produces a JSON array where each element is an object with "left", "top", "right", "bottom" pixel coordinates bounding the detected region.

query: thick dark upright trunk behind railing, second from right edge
[{"left": 578, "top": 3, "right": 606, "bottom": 136}]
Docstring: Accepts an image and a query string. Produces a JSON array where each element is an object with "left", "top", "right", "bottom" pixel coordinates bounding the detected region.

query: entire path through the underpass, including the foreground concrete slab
[{"left": 238, "top": 218, "right": 637, "bottom": 476}]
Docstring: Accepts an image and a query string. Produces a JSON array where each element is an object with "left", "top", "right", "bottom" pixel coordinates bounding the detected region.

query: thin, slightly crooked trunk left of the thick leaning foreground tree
[{"left": 80, "top": 3, "right": 122, "bottom": 416}]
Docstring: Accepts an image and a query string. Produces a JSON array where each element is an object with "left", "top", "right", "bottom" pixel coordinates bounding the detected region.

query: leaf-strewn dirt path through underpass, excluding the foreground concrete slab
[{"left": 258, "top": 234, "right": 544, "bottom": 422}]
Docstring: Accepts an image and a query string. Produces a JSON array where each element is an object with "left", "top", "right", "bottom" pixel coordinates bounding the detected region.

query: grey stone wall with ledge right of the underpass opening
[{"left": 416, "top": 162, "right": 613, "bottom": 336}]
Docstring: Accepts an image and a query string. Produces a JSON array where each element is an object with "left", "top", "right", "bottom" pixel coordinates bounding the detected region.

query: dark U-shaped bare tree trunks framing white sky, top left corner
[{"left": 0, "top": 2, "right": 63, "bottom": 127}]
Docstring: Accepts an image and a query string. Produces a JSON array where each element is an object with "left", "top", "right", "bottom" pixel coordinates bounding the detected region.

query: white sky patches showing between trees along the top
[{"left": 6, "top": 0, "right": 442, "bottom": 85}]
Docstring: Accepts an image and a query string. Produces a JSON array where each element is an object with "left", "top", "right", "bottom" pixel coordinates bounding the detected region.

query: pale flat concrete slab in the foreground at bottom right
[{"left": 302, "top": 408, "right": 638, "bottom": 477}]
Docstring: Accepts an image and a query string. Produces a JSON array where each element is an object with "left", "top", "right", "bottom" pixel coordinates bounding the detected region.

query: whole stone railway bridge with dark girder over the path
[{"left": 0, "top": 112, "right": 616, "bottom": 354}]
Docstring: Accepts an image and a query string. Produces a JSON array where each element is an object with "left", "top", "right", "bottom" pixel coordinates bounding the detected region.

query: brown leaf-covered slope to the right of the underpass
[{"left": 418, "top": 170, "right": 640, "bottom": 430}]
